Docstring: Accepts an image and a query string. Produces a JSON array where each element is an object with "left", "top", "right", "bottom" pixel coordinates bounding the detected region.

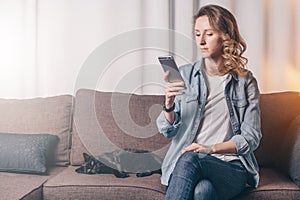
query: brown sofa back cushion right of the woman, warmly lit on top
[{"left": 255, "top": 92, "right": 300, "bottom": 167}]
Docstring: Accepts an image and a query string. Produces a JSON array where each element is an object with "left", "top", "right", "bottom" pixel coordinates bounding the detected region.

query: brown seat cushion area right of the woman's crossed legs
[{"left": 235, "top": 168, "right": 300, "bottom": 200}]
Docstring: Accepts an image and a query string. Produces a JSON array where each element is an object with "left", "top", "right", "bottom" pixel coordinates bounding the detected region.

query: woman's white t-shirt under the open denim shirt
[{"left": 195, "top": 71, "right": 238, "bottom": 161}]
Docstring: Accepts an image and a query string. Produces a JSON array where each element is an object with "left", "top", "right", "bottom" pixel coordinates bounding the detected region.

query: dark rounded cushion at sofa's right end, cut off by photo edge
[{"left": 274, "top": 115, "right": 300, "bottom": 187}]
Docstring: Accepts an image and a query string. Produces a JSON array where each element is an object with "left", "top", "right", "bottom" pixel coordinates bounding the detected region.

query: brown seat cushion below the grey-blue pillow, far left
[{"left": 0, "top": 167, "right": 66, "bottom": 200}]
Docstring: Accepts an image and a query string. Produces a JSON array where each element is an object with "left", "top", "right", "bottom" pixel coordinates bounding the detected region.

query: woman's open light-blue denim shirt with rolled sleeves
[{"left": 157, "top": 60, "right": 262, "bottom": 187}]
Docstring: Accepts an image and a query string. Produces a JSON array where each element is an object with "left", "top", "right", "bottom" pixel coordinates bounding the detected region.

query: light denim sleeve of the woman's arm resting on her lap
[{"left": 231, "top": 76, "right": 262, "bottom": 156}]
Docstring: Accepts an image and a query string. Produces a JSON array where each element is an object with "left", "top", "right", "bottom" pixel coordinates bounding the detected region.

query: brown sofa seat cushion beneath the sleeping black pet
[{"left": 43, "top": 166, "right": 166, "bottom": 200}]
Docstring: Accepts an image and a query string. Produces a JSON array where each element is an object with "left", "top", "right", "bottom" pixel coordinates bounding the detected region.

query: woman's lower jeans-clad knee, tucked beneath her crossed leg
[{"left": 194, "top": 179, "right": 217, "bottom": 200}]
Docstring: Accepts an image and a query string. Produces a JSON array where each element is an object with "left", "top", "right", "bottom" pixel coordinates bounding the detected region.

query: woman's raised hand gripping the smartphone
[{"left": 164, "top": 71, "right": 186, "bottom": 108}]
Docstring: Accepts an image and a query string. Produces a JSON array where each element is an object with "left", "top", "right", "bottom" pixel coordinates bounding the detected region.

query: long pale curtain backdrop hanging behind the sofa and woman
[{"left": 0, "top": 0, "right": 300, "bottom": 98}]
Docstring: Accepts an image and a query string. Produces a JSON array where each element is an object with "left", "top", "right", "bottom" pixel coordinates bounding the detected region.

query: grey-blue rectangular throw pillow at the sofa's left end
[{"left": 0, "top": 133, "right": 58, "bottom": 174}]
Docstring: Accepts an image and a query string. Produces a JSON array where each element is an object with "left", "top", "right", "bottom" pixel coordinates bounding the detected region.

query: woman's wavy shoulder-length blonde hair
[{"left": 194, "top": 5, "right": 248, "bottom": 76}]
